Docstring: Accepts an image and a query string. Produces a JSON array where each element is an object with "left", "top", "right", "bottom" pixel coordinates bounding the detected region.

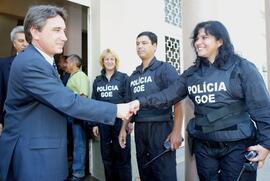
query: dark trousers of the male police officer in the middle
[{"left": 135, "top": 122, "right": 177, "bottom": 181}]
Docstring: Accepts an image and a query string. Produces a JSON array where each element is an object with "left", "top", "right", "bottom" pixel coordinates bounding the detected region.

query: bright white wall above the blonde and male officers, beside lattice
[{"left": 90, "top": 0, "right": 181, "bottom": 77}]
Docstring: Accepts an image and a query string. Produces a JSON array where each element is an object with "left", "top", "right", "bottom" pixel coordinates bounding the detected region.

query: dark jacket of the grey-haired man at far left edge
[{"left": 0, "top": 56, "right": 15, "bottom": 124}]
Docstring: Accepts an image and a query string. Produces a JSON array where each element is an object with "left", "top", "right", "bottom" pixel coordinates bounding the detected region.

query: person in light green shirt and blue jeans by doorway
[{"left": 66, "top": 54, "right": 90, "bottom": 181}]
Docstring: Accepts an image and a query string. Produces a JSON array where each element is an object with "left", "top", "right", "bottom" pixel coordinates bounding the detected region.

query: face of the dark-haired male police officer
[{"left": 136, "top": 35, "right": 157, "bottom": 60}]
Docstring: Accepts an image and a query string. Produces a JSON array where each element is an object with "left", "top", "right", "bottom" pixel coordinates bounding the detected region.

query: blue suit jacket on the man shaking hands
[{"left": 0, "top": 45, "right": 117, "bottom": 181}]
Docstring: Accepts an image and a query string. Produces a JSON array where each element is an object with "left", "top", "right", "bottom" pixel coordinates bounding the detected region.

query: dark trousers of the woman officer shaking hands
[{"left": 194, "top": 140, "right": 257, "bottom": 181}]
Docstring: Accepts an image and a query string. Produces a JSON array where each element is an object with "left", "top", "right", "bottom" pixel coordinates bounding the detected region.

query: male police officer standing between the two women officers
[{"left": 119, "top": 31, "right": 183, "bottom": 181}]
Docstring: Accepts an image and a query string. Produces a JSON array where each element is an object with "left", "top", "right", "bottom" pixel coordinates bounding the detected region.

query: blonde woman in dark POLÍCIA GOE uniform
[{"left": 92, "top": 49, "right": 132, "bottom": 181}]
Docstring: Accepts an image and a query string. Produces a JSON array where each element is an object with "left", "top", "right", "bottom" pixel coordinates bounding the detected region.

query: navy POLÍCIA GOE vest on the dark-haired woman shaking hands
[{"left": 187, "top": 60, "right": 254, "bottom": 141}]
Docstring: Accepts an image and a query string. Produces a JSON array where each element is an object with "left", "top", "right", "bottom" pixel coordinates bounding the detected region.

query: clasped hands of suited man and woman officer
[{"left": 117, "top": 100, "right": 140, "bottom": 121}]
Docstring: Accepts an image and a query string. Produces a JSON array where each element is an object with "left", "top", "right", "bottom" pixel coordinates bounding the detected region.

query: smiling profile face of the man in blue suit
[{"left": 30, "top": 15, "right": 67, "bottom": 57}]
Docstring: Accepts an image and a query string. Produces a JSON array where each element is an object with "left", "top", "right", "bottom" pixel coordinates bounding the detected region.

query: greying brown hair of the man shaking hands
[{"left": 24, "top": 5, "right": 67, "bottom": 43}]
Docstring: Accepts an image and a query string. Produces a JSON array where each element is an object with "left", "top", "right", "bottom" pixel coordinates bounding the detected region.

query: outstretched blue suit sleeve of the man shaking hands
[{"left": 21, "top": 61, "right": 117, "bottom": 125}]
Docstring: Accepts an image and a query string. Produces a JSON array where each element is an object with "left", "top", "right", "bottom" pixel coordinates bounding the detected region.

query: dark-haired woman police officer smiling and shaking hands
[{"left": 131, "top": 21, "right": 270, "bottom": 180}]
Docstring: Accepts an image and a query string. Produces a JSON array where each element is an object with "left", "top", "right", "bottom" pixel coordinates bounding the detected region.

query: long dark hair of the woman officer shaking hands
[{"left": 192, "top": 21, "right": 235, "bottom": 67}]
